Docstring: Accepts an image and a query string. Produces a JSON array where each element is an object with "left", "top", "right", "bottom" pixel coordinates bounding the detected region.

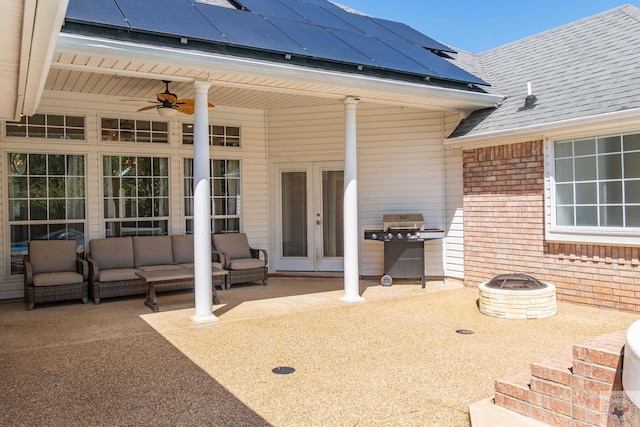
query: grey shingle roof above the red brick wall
[{"left": 449, "top": 5, "right": 640, "bottom": 138}]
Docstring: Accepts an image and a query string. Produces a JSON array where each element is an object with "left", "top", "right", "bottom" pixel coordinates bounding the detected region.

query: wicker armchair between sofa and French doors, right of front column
[{"left": 213, "top": 233, "right": 269, "bottom": 289}]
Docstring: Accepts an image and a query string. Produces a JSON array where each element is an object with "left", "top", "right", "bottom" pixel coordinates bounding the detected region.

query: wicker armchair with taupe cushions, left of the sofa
[{"left": 23, "top": 240, "right": 89, "bottom": 310}]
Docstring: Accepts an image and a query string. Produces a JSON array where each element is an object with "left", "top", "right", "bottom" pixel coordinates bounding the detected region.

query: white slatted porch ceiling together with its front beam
[{"left": 44, "top": 32, "right": 502, "bottom": 112}]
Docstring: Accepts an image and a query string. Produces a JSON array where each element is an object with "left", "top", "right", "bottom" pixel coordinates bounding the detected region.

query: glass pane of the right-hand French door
[{"left": 322, "top": 171, "right": 344, "bottom": 257}]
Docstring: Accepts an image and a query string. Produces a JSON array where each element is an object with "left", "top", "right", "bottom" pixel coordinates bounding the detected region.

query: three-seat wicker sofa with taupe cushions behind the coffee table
[{"left": 87, "top": 235, "right": 226, "bottom": 304}]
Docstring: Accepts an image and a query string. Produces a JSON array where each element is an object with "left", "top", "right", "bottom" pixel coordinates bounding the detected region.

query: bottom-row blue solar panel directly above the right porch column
[{"left": 268, "top": 17, "right": 371, "bottom": 65}]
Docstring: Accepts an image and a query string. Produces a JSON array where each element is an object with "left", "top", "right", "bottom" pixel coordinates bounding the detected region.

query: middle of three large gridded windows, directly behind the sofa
[{"left": 103, "top": 156, "right": 169, "bottom": 237}]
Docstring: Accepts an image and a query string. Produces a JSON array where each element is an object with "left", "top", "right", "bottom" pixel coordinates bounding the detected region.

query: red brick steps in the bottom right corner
[{"left": 495, "top": 330, "right": 640, "bottom": 427}]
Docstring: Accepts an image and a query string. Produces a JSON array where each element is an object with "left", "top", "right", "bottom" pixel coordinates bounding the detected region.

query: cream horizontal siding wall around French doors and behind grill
[{"left": 268, "top": 103, "right": 444, "bottom": 276}]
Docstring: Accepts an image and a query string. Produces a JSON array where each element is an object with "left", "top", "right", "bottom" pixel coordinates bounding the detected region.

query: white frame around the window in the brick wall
[{"left": 544, "top": 135, "right": 640, "bottom": 246}]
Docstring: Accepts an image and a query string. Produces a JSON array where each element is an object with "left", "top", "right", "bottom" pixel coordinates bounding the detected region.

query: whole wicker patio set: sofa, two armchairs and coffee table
[{"left": 24, "top": 233, "right": 268, "bottom": 311}]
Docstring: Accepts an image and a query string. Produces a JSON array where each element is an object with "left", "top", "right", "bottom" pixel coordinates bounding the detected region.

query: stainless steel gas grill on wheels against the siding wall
[{"left": 364, "top": 214, "right": 444, "bottom": 288}]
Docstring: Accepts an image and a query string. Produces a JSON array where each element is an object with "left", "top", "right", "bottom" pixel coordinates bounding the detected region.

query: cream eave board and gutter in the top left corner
[{"left": 14, "top": 0, "right": 69, "bottom": 120}]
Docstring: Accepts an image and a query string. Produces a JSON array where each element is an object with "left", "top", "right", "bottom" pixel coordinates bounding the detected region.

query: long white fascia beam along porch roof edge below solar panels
[{"left": 52, "top": 32, "right": 503, "bottom": 111}]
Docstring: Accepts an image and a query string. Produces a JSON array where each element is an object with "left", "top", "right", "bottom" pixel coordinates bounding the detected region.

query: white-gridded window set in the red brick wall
[{"left": 550, "top": 133, "right": 640, "bottom": 243}]
